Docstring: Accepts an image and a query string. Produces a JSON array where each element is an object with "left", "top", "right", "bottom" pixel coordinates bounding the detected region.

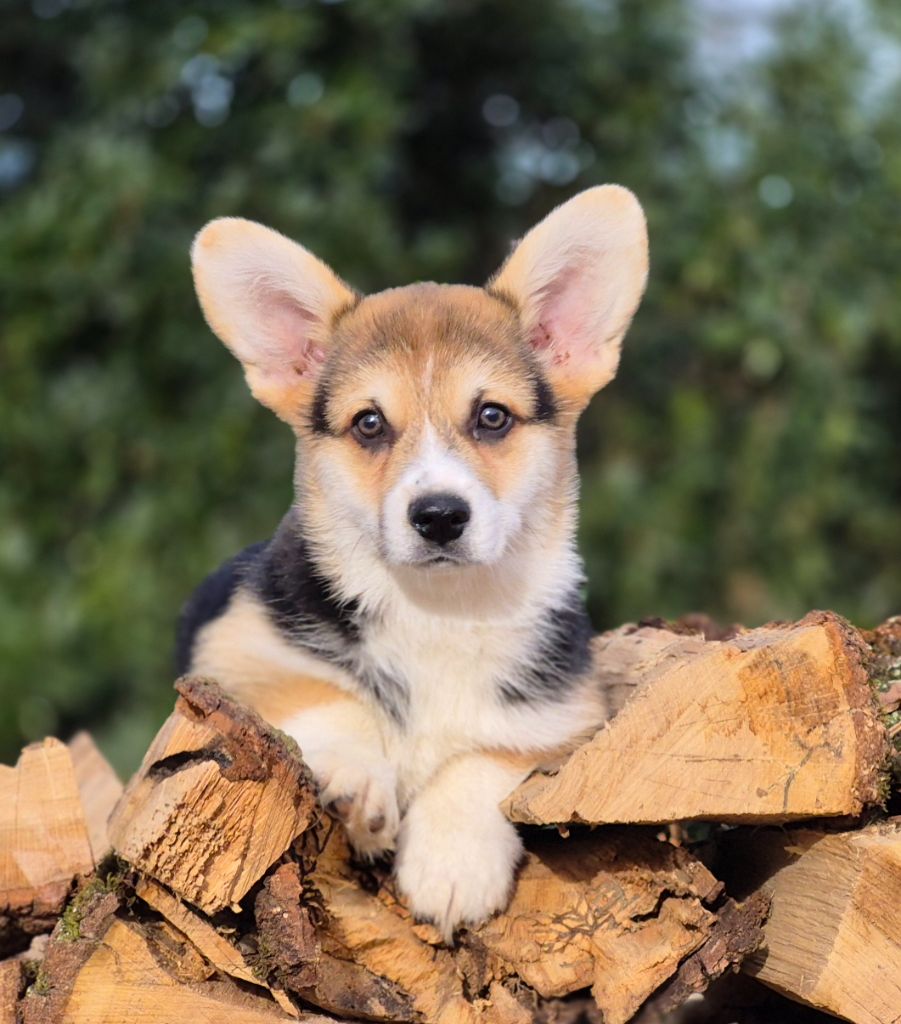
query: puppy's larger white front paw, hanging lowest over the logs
[{"left": 395, "top": 802, "right": 522, "bottom": 942}]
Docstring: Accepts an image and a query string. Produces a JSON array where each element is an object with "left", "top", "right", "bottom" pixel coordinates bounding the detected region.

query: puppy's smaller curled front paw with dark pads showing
[{"left": 316, "top": 758, "right": 400, "bottom": 859}]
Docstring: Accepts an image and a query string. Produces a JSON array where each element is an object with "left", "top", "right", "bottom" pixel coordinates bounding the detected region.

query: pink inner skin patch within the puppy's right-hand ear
[{"left": 531, "top": 263, "right": 600, "bottom": 366}]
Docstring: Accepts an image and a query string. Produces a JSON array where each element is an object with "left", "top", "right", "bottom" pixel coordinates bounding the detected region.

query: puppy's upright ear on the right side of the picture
[{"left": 487, "top": 185, "right": 648, "bottom": 409}]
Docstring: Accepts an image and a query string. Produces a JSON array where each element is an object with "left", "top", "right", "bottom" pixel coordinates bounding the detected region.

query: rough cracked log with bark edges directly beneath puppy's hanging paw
[{"left": 303, "top": 829, "right": 722, "bottom": 1024}]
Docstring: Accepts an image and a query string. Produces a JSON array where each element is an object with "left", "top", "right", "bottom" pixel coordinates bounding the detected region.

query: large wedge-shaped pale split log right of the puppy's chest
[{"left": 505, "top": 612, "right": 889, "bottom": 824}]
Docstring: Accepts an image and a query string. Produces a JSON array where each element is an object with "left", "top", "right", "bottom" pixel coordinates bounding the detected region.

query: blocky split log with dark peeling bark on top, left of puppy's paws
[{"left": 110, "top": 678, "right": 318, "bottom": 913}]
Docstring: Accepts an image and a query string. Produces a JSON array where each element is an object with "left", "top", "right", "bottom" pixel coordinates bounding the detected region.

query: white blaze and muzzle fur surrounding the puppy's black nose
[{"left": 381, "top": 421, "right": 521, "bottom": 565}]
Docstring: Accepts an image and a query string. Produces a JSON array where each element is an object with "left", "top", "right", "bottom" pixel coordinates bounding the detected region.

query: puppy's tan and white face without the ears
[{"left": 297, "top": 285, "right": 561, "bottom": 568}]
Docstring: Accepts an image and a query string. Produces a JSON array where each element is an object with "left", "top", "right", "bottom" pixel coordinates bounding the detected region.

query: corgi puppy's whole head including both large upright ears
[{"left": 192, "top": 186, "right": 647, "bottom": 573}]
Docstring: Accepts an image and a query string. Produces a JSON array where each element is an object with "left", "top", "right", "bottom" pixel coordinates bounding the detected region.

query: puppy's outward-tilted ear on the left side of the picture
[{"left": 190, "top": 217, "right": 356, "bottom": 423}]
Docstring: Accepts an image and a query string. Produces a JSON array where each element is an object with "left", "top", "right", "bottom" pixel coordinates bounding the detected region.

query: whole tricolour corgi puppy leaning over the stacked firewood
[{"left": 178, "top": 185, "right": 647, "bottom": 938}]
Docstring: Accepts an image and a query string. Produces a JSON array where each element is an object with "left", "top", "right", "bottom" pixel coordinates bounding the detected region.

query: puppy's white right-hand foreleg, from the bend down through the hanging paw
[{"left": 396, "top": 752, "right": 537, "bottom": 941}]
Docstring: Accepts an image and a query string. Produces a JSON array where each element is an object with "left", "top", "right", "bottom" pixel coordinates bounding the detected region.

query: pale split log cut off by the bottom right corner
[{"left": 727, "top": 818, "right": 901, "bottom": 1024}]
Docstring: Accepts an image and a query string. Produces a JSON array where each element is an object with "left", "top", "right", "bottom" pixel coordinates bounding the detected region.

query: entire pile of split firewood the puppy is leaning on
[{"left": 0, "top": 612, "right": 901, "bottom": 1024}]
